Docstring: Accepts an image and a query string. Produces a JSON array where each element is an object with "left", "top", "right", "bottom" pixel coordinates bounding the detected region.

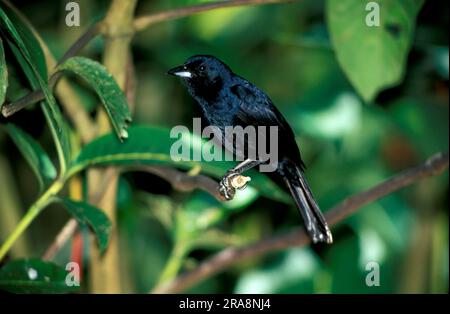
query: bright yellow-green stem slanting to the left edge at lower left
[{"left": 0, "top": 179, "right": 65, "bottom": 261}]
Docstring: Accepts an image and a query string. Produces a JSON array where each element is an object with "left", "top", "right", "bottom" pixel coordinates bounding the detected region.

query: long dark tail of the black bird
[{"left": 283, "top": 163, "right": 333, "bottom": 243}]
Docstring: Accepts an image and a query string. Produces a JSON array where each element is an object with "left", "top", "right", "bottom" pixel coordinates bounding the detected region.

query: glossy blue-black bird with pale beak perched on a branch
[{"left": 168, "top": 55, "right": 333, "bottom": 243}]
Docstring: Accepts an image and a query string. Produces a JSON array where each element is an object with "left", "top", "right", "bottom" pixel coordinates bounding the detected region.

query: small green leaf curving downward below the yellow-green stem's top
[{"left": 59, "top": 198, "right": 112, "bottom": 253}]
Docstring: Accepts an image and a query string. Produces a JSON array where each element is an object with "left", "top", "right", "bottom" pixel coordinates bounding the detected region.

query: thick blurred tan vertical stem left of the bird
[{"left": 88, "top": 0, "right": 137, "bottom": 293}]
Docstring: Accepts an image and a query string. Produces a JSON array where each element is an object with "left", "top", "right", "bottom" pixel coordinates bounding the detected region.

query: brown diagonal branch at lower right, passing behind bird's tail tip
[{"left": 151, "top": 152, "right": 449, "bottom": 293}]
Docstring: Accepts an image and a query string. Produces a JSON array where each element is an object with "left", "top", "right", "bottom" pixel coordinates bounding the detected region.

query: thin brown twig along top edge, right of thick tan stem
[{"left": 134, "top": 0, "right": 295, "bottom": 31}]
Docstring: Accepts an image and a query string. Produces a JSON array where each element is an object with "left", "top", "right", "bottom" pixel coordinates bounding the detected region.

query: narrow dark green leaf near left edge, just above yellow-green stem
[{"left": 5, "top": 124, "right": 57, "bottom": 189}]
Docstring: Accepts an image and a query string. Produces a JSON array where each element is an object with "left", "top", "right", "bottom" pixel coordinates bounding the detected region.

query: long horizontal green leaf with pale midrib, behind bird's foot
[{"left": 69, "top": 126, "right": 289, "bottom": 202}]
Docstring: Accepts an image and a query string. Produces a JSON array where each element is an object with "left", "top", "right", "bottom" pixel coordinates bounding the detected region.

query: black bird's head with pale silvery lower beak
[{"left": 167, "top": 55, "right": 232, "bottom": 96}]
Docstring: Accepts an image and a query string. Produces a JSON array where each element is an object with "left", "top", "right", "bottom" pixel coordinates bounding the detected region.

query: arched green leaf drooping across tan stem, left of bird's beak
[{"left": 57, "top": 57, "right": 131, "bottom": 140}]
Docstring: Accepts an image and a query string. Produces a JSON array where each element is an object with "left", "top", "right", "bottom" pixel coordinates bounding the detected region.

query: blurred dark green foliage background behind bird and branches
[{"left": 0, "top": 0, "right": 449, "bottom": 293}]
